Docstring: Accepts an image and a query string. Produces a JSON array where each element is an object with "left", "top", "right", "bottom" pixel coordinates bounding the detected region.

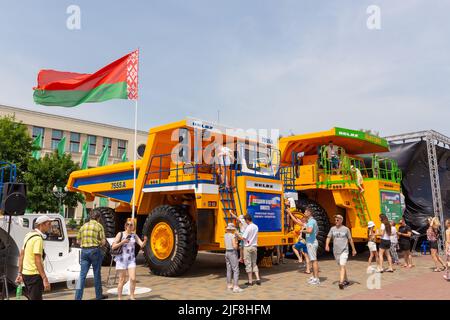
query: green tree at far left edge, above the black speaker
[{"left": 0, "top": 115, "right": 38, "bottom": 181}]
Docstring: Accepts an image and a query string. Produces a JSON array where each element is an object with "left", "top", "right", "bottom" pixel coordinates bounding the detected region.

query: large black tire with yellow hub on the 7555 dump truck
[{"left": 143, "top": 205, "right": 198, "bottom": 277}]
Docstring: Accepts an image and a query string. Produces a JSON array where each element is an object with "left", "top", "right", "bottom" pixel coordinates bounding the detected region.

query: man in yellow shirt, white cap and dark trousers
[{"left": 16, "top": 215, "right": 54, "bottom": 300}]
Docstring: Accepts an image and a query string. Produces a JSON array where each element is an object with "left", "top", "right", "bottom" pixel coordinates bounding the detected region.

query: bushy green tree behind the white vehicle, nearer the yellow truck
[{"left": 24, "top": 150, "right": 83, "bottom": 212}]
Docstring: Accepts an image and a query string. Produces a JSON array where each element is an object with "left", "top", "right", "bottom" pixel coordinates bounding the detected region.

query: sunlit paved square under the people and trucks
[{"left": 44, "top": 252, "right": 450, "bottom": 300}]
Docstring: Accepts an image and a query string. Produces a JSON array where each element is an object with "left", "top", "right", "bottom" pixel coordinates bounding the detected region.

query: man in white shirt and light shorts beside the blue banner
[{"left": 240, "top": 214, "right": 261, "bottom": 286}]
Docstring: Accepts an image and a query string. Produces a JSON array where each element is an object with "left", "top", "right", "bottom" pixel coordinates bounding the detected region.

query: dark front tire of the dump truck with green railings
[{"left": 295, "top": 196, "right": 330, "bottom": 256}]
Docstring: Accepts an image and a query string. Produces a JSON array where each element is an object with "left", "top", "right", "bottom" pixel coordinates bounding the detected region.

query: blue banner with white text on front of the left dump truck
[{"left": 247, "top": 192, "right": 281, "bottom": 232}]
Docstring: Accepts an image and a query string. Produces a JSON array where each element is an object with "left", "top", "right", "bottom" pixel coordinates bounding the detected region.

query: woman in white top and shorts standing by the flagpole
[{"left": 112, "top": 218, "right": 147, "bottom": 300}]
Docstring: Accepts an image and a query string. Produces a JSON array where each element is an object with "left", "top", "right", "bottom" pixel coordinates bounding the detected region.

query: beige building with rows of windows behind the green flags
[{"left": 0, "top": 105, "right": 148, "bottom": 219}]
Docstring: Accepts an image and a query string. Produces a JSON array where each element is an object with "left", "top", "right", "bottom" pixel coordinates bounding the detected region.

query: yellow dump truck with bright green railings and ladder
[{"left": 279, "top": 127, "right": 402, "bottom": 253}]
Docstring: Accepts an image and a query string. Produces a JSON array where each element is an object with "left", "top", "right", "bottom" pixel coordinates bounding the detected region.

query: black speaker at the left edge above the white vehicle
[{"left": 2, "top": 182, "right": 27, "bottom": 216}]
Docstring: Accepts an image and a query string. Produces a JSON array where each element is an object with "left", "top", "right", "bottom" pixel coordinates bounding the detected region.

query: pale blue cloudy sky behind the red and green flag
[{"left": 0, "top": 0, "right": 450, "bottom": 135}]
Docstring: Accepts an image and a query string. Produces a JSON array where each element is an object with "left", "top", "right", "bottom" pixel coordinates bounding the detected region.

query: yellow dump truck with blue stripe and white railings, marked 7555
[{"left": 67, "top": 118, "right": 294, "bottom": 276}]
